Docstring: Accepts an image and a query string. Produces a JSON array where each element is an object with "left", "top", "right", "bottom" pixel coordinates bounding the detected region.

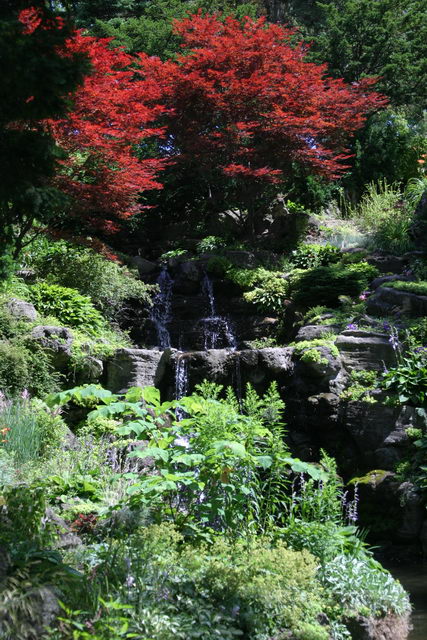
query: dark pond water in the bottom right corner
[{"left": 388, "top": 562, "right": 427, "bottom": 640}]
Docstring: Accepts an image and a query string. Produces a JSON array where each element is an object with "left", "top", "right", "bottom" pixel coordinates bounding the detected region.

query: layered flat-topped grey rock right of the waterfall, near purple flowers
[{"left": 335, "top": 330, "right": 396, "bottom": 371}]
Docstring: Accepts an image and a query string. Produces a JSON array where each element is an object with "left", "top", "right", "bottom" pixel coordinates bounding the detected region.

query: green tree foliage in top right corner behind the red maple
[{"left": 311, "top": 0, "right": 427, "bottom": 113}]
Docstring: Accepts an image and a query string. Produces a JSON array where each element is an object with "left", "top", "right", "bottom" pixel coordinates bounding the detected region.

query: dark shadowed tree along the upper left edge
[{"left": 0, "top": 0, "right": 89, "bottom": 272}]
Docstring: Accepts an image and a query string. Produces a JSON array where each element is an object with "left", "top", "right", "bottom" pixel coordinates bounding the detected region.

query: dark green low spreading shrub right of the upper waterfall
[{"left": 292, "top": 262, "right": 378, "bottom": 308}]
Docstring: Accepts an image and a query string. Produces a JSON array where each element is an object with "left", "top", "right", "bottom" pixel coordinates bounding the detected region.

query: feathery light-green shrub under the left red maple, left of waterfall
[{"left": 27, "top": 240, "right": 153, "bottom": 326}]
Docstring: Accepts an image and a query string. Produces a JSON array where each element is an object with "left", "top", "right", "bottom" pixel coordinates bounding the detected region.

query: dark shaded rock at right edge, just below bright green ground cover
[{"left": 367, "top": 287, "right": 427, "bottom": 318}]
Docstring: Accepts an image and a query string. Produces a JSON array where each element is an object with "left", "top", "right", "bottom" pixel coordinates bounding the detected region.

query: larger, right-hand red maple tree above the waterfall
[{"left": 139, "top": 13, "right": 386, "bottom": 225}]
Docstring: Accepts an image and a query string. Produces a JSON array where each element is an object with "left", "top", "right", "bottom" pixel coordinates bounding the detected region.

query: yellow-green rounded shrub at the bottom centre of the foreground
[{"left": 177, "top": 539, "right": 328, "bottom": 640}]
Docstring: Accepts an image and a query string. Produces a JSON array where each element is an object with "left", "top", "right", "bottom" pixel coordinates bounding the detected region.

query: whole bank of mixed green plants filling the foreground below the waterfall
[{"left": 0, "top": 383, "right": 409, "bottom": 640}]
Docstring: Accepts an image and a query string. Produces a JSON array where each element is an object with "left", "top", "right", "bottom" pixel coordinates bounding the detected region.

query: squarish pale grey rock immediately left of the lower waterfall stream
[{"left": 107, "top": 349, "right": 170, "bottom": 393}]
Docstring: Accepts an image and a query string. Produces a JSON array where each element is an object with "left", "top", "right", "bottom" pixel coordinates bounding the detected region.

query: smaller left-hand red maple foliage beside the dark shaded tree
[{"left": 47, "top": 33, "right": 164, "bottom": 233}]
